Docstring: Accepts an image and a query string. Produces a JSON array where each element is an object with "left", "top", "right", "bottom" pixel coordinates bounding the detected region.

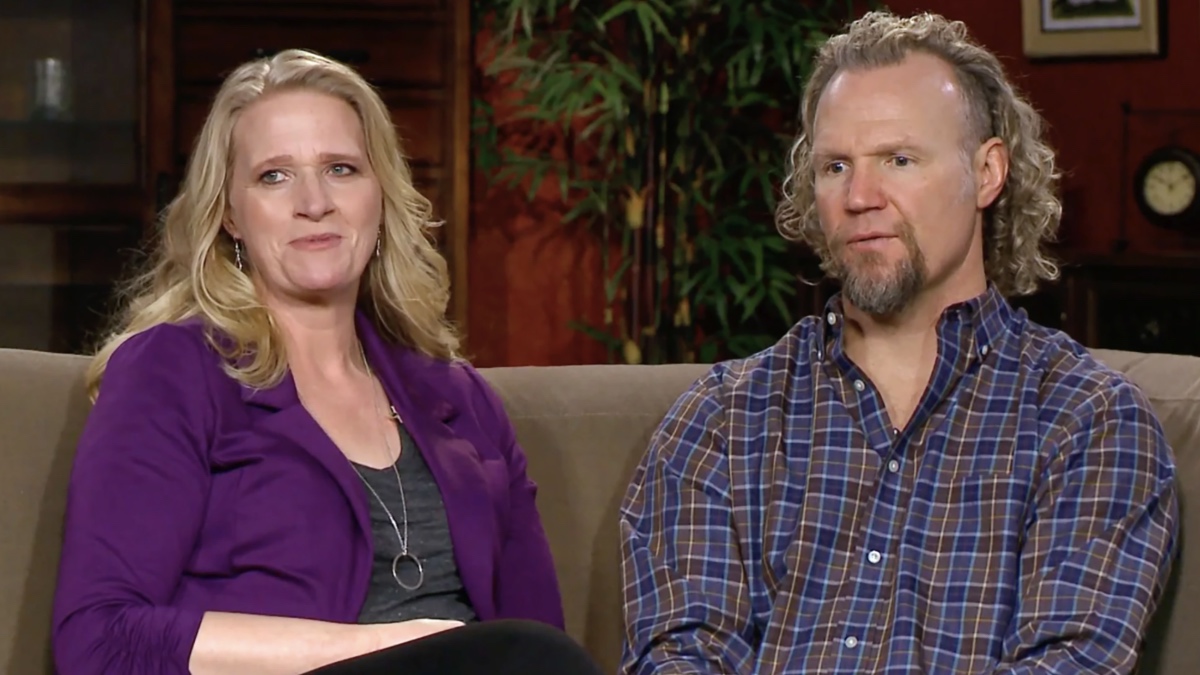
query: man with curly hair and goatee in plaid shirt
[{"left": 620, "top": 12, "right": 1178, "bottom": 675}]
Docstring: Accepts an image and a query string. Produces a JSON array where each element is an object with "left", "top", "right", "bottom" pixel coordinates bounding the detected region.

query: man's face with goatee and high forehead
[{"left": 812, "top": 53, "right": 983, "bottom": 317}]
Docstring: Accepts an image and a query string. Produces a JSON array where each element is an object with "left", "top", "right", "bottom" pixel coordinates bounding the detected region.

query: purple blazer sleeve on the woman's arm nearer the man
[{"left": 466, "top": 365, "right": 565, "bottom": 628}]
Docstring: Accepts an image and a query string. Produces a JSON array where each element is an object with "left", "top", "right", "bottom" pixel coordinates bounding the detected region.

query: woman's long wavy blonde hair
[{"left": 86, "top": 49, "right": 460, "bottom": 399}]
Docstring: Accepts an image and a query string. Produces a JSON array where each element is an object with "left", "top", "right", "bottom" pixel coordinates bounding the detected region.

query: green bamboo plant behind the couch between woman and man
[{"left": 473, "top": 0, "right": 853, "bottom": 363}]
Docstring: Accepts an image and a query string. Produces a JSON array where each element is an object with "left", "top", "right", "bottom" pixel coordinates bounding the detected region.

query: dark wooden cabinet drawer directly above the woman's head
[{"left": 182, "top": 16, "right": 450, "bottom": 86}]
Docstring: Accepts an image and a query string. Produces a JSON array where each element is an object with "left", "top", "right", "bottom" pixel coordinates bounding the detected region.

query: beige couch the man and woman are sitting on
[{"left": 0, "top": 350, "right": 1200, "bottom": 675}]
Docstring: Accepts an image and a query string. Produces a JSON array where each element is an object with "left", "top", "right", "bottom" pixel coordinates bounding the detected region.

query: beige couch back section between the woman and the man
[{"left": 482, "top": 365, "right": 708, "bottom": 673}]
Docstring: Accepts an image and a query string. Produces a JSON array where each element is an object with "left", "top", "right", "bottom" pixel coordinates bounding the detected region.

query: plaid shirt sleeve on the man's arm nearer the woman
[{"left": 619, "top": 375, "right": 755, "bottom": 675}]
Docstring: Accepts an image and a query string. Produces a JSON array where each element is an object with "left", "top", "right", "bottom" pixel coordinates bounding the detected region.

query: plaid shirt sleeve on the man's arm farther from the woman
[{"left": 995, "top": 380, "right": 1178, "bottom": 675}]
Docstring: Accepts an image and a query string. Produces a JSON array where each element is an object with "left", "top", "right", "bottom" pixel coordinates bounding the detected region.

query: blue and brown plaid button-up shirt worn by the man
[{"left": 620, "top": 288, "right": 1178, "bottom": 675}]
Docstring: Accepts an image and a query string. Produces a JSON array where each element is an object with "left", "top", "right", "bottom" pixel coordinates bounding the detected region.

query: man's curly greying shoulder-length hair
[{"left": 775, "top": 11, "right": 1062, "bottom": 295}]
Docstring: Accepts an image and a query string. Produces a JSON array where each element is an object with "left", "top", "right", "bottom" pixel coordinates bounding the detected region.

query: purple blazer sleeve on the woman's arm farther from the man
[{"left": 53, "top": 325, "right": 215, "bottom": 675}]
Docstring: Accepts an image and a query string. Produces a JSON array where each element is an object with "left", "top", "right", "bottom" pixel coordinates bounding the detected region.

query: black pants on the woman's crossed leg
[{"left": 310, "top": 621, "right": 601, "bottom": 675}]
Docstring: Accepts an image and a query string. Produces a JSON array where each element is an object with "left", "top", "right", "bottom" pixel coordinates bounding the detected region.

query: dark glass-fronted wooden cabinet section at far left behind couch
[{"left": 0, "top": 0, "right": 169, "bottom": 351}]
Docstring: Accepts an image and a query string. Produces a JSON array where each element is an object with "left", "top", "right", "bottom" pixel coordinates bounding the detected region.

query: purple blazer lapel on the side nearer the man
[{"left": 359, "top": 313, "right": 500, "bottom": 617}]
